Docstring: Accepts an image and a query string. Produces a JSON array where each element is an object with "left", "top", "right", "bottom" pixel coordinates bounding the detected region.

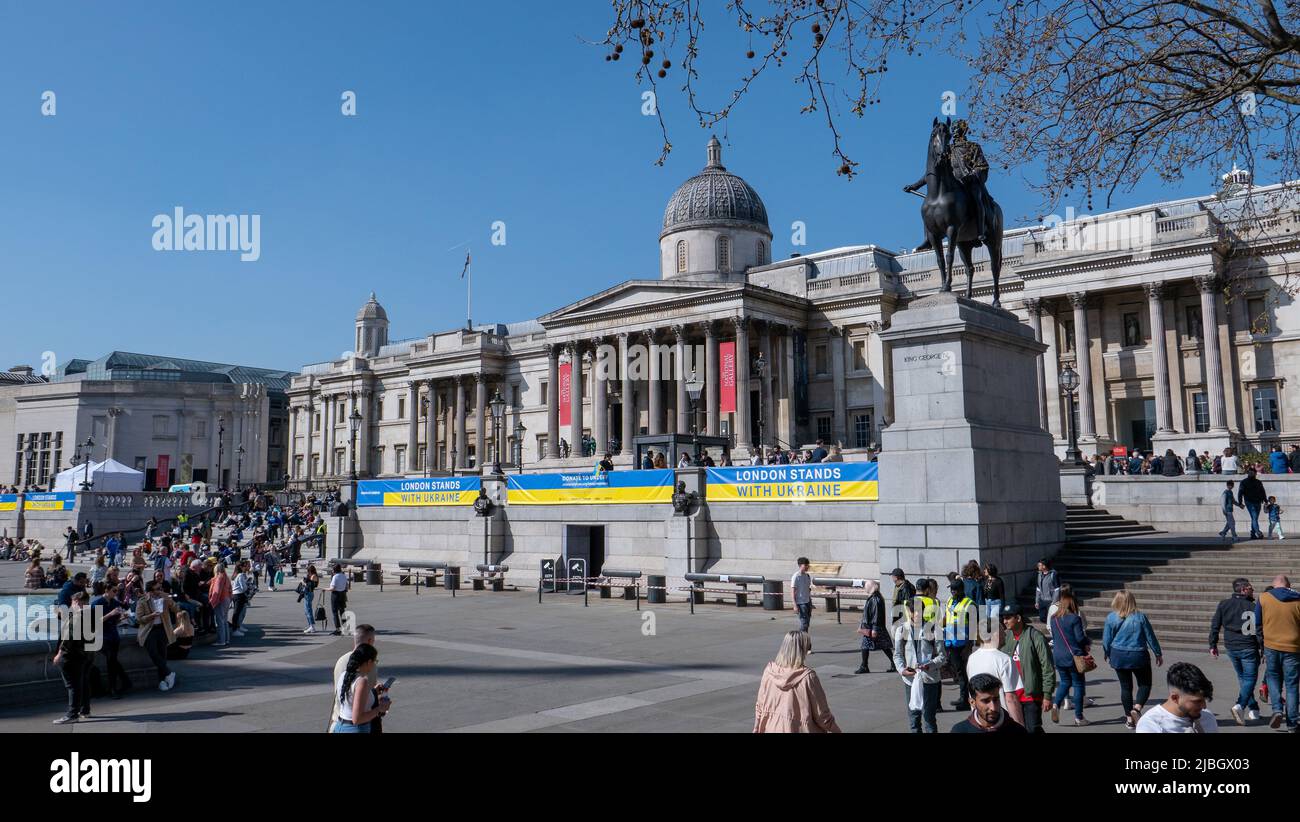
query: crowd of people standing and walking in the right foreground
[{"left": 754, "top": 557, "right": 1300, "bottom": 734}]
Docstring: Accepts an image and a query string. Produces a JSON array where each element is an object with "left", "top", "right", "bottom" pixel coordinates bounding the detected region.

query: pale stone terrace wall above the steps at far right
[{"left": 1092, "top": 473, "right": 1300, "bottom": 536}]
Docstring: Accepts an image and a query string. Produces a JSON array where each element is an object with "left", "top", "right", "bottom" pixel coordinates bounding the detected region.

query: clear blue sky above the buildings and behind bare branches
[{"left": 0, "top": 0, "right": 1217, "bottom": 369}]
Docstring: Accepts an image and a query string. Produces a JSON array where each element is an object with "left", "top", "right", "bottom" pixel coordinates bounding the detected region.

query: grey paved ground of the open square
[{"left": 0, "top": 563, "right": 1270, "bottom": 734}]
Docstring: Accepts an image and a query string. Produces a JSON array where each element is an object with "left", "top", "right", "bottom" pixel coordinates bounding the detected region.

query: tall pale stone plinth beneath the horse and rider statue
[{"left": 876, "top": 293, "right": 1065, "bottom": 597}]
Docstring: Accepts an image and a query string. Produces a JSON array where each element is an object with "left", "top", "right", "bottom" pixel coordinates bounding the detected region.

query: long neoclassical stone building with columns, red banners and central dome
[{"left": 287, "top": 139, "right": 1300, "bottom": 486}]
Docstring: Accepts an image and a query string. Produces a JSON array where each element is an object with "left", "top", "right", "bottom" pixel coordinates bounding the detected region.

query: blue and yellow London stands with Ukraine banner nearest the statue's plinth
[{"left": 707, "top": 463, "right": 880, "bottom": 502}]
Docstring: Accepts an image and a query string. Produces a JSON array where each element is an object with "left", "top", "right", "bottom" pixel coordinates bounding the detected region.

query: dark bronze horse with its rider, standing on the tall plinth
[{"left": 904, "top": 117, "right": 1002, "bottom": 308}]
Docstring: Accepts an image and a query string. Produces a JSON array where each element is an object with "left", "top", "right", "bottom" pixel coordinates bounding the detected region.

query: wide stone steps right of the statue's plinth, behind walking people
[{"left": 1030, "top": 532, "right": 1300, "bottom": 658}]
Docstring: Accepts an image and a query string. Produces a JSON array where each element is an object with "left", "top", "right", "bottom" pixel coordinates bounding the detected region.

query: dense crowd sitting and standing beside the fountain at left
[{"left": 46, "top": 489, "right": 346, "bottom": 724}]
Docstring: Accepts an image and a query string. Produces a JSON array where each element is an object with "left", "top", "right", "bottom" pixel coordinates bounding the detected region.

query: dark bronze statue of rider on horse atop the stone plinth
[{"left": 904, "top": 117, "right": 1002, "bottom": 307}]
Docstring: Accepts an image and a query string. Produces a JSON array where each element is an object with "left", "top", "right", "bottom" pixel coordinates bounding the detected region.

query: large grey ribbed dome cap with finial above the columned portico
[{"left": 659, "top": 137, "right": 772, "bottom": 238}]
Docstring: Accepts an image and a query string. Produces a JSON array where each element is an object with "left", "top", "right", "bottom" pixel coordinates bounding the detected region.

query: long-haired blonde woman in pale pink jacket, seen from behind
[{"left": 754, "top": 631, "right": 840, "bottom": 734}]
